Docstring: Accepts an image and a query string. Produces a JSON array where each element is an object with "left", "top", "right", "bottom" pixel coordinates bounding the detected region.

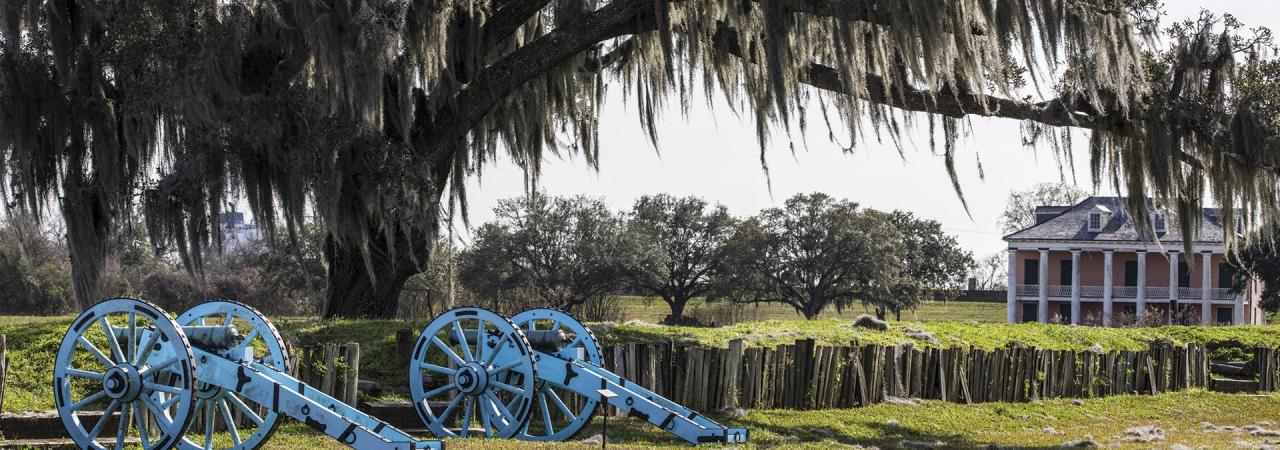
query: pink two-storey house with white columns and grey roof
[{"left": 1005, "top": 197, "right": 1265, "bottom": 326}]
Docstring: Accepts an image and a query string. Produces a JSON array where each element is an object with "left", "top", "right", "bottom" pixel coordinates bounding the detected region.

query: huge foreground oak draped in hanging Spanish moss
[{"left": 0, "top": 0, "right": 1280, "bottom": 317}]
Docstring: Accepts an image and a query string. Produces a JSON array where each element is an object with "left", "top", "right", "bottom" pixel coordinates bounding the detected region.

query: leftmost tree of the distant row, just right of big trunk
[{"left": 458, "top": 194, "right": 628, "bottom": 311}]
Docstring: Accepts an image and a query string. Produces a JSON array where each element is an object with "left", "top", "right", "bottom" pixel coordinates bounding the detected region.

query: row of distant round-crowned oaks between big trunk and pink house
[{"left": 457, "top": 193, "right": 975, "bottom": 323}]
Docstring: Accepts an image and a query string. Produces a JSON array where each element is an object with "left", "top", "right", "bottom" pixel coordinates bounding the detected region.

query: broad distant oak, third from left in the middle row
[{"left": 716, "top": 193, "right": 905, "bottom": 318}]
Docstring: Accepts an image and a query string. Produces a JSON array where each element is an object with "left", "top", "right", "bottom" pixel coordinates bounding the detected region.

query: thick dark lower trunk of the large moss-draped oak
[{"left": 324, "top": 230, "right": 430, "bottom": 318}]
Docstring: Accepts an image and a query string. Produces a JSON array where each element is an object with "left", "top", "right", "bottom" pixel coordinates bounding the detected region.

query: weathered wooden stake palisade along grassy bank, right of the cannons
[{"left": 593, "top": 340, "right": 1213, "bottom": 410}]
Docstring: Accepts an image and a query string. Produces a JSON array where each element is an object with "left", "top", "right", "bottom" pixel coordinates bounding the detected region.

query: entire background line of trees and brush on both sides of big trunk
[{"left": 0, "top": 193, "right": 975, "bottom": 323}]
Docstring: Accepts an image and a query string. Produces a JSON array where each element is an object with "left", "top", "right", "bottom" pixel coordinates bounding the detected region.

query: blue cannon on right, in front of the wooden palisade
[{"left": 408, "top": 307, "right": 748, "bottom": 444}]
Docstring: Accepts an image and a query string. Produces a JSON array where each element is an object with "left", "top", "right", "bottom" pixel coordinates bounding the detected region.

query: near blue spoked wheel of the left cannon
[{"left": 54, "top": 298, "right": 196, "bottom": 449}]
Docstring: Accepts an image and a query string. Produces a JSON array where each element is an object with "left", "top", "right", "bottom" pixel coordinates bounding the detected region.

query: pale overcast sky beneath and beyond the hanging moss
[{"left": 456, "top": 0, "right": 1280, "bottom": 257}]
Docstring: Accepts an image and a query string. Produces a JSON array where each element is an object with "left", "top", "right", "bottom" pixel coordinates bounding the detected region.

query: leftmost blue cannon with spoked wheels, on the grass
[{"left": 54, "top": 298, "right": 444, "bottom": 450}]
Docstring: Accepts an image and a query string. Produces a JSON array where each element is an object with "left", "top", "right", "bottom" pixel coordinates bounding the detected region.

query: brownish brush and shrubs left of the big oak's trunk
[{"left": 0, "top": 211, "right": 325, "bottom": 316}]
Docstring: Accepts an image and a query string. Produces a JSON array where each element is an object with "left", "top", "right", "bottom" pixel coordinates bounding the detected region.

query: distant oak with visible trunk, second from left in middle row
[{"left": 626, "top": 194, "right": 735, "bottom": 323}]
